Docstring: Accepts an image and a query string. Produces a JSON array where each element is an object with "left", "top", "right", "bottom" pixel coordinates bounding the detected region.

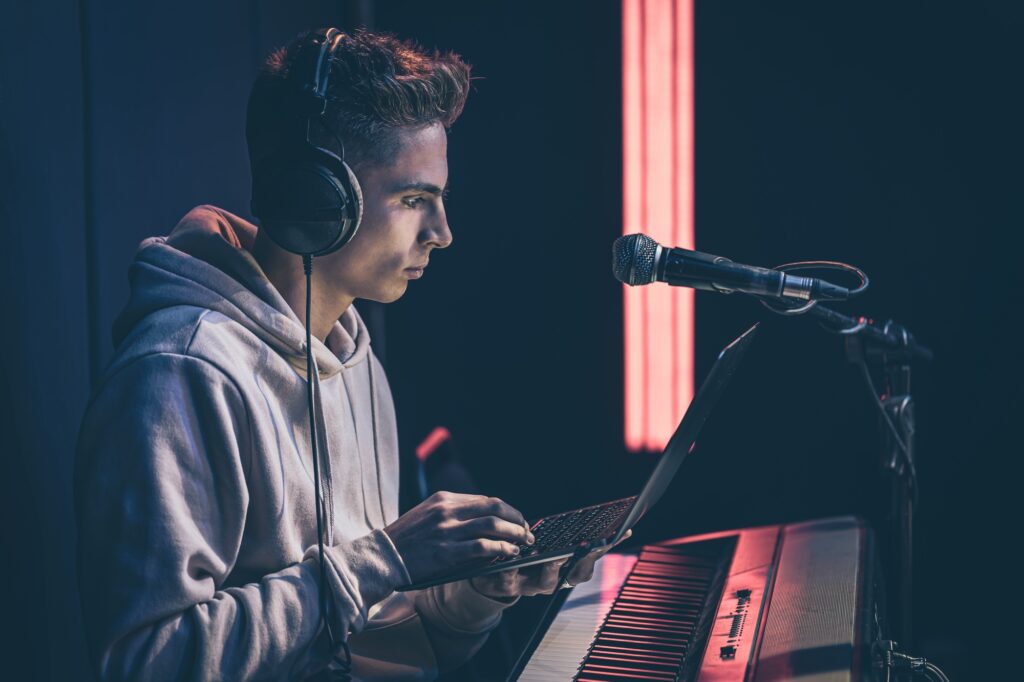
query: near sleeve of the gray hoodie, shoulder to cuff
[{"left": 75, "top": 353, "right": 408, "bottom": 680}]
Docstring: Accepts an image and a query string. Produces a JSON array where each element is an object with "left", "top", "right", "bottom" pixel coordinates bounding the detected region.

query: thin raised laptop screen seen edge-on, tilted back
[{"left": 611, "top": 323, "right": 760, "bottom": 544}]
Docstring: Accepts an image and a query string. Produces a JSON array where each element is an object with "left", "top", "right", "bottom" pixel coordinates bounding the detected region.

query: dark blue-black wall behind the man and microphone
[{"left": 0, "top": 0, "right": 1024, "bottom": 680}]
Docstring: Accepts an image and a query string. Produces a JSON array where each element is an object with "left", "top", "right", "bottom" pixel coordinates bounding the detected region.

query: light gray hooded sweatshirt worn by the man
[{"left": 75, "top": 206, "right": 508, "bottom": 680}]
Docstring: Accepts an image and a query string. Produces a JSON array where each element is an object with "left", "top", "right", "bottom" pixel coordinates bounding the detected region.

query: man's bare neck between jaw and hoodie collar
[{"left": 253, "top": 237, "right": 352, "bottom": 341}]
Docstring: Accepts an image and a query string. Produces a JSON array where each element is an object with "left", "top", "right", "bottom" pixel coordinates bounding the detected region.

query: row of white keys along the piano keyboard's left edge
[{"left": 519, "top": 554, "right": 637, "bottom": 682}]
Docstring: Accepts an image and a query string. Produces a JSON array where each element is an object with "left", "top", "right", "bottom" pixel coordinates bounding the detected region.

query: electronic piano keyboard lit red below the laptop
[{"left": 517, "top": 517, "right": 877, "bottom": 682}]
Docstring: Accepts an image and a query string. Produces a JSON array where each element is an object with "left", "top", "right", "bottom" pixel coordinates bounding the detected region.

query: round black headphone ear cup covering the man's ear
[{"left": 252, "top": 146, "right": 362, "bottom": 256}]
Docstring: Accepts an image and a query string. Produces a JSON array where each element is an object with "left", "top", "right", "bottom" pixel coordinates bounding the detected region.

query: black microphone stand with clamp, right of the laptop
[{"left": 807, "top": 305, "right": 933, "bottom": 645}]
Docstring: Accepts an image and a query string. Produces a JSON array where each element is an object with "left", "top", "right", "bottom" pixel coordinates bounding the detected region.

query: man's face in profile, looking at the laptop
[{"left": 321, "top": 123, "right": 452, "bottom": 303}]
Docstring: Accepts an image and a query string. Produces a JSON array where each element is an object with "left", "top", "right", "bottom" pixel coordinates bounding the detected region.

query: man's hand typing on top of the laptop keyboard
[{"left": 384, "top": 492, "right": 534, "bottom": 583}]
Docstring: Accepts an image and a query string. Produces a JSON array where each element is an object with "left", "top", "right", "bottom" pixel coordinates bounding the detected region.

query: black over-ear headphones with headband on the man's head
[{"left": 251, "top": 29, "right": 362, "bottom": 256}]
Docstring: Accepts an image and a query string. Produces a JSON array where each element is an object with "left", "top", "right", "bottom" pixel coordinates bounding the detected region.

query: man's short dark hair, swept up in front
[{"left": 246, "top": 30, "right": 470, "bottom": 165}]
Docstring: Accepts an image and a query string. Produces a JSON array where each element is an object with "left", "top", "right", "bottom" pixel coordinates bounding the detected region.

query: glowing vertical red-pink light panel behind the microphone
[{"left": 623, "top": 0, "right": 693, "bottom": 451}]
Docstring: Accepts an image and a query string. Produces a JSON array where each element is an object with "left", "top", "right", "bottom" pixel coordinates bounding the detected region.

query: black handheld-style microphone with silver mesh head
[{"left": 611, "top": 235, "right": 850, "bottom": 301}]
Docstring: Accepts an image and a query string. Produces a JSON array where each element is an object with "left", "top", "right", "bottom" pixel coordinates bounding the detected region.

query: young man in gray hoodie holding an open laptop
[{"left": 75, "top": 33, "right": 614, "bottom": 680}]
